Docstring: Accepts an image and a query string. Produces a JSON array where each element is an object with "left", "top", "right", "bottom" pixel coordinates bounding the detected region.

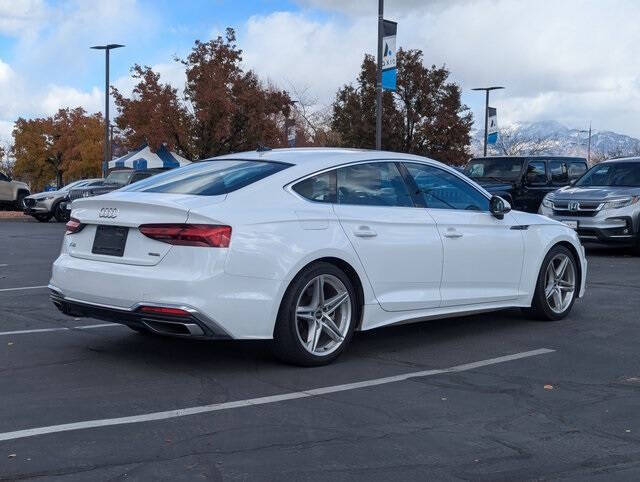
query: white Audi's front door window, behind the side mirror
[{"left": 405, "top": 163, "right": 489, "bottom": 211}]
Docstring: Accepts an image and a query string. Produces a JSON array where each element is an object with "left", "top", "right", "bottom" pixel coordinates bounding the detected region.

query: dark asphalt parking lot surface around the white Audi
[{"left": 0, "top": 221, "right": 640, "bottom": 481}]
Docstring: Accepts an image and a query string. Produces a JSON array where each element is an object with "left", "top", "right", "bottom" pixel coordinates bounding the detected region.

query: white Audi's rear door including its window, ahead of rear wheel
[{"left": 334, "top": 162, "right": 442, "bottom": 311}]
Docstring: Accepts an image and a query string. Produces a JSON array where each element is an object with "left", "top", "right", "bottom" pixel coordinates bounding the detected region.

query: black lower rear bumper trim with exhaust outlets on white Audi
[{"left": 49, "top": 285, "right": 231, "bottom": 340}]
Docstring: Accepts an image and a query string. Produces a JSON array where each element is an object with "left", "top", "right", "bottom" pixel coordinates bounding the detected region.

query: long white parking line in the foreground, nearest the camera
[{"left": 0, "top": 348, "right": 555, "bottom": 441}]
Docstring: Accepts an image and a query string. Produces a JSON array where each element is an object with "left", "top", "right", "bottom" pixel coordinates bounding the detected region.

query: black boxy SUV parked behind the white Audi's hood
[{"left": 464, "top": 156, "right": 588, "bottom": 213}]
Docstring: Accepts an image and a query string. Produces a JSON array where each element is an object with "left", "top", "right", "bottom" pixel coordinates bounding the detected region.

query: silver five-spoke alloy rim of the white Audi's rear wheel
[{"left": 296, "top": 274, "right": 351, "bottom": 356}]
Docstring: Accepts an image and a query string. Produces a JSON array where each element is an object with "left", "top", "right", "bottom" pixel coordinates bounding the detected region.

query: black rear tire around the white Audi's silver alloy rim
[{"left": 273, "top": 262, "right": 361, "bottom": 367}]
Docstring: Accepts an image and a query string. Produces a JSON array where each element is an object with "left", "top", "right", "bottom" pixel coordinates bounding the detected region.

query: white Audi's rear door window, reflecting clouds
[{"left": 337, "top": 162, "right": 413, "bottom": 206}]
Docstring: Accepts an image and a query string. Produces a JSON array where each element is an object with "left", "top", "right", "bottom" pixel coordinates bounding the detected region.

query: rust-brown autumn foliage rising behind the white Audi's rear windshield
[{"left": 112, "top": 28, "right": 291, "bottom": 160}]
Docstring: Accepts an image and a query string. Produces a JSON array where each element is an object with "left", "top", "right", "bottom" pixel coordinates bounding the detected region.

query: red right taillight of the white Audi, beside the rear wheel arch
[{"left": 138, "top": 224, "right": 231, "bottom": 248}]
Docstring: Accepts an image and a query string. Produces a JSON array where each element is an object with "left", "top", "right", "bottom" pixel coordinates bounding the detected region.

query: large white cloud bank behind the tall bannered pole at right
[{"left": 240, "top": 0, "right": 640, "bottom": 136}]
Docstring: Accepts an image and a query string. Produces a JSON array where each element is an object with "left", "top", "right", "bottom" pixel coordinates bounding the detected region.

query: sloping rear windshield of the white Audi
[{"left": 122, "top": 159, "right": 290, "bottom": 196}]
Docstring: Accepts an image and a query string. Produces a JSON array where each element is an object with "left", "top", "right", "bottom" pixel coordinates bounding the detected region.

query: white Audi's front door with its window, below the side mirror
[{"left": 404, "top": 162, "right": 524, "bottom": 306}]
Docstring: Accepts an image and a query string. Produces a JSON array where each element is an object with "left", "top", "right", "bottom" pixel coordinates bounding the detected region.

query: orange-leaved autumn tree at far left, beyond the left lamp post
[{"left": 12, "top": 107, "right": 104, "bottom": 192}]
